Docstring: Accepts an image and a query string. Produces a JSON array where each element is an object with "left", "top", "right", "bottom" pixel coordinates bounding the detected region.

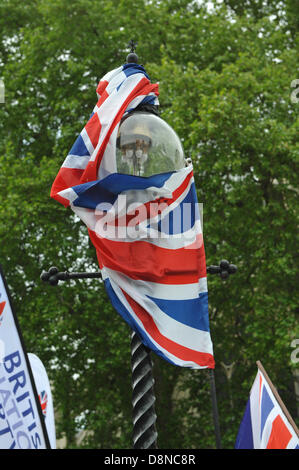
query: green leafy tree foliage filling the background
[{"left": 0, "top": 0, "right": 298, "bottom": 448}]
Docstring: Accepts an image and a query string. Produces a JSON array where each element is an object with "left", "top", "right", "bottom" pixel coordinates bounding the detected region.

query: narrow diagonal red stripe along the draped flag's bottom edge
[{"left": 122, "top": 290, "right": 215, "bottom": 369}]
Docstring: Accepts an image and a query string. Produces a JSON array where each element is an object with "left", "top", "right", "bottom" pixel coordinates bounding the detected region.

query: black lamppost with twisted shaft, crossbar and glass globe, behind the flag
[{"left": 41, "top": 42, "right": 236, "bottom": 449}]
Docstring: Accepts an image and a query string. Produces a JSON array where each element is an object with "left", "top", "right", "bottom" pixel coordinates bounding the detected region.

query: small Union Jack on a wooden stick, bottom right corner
[{"left": 235, "top": 364, "right": 299, "bottom": 449}]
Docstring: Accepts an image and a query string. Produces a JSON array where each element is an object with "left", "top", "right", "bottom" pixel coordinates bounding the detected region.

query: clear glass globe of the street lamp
[{"left": 116, "top": 111, "right": 185, "bottom": 176}]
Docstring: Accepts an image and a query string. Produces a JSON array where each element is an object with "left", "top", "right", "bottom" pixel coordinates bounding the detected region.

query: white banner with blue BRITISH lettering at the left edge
[{"left": 0, "top": 266, "right": 50, "bottom": 449}]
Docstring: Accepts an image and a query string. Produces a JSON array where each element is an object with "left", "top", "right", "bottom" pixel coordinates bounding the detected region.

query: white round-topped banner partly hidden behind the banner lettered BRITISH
[{"left": 28, "top": 353, "right": 56, "bottom": 449}]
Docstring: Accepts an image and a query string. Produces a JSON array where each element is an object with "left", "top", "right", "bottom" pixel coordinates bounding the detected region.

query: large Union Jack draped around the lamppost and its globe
[{"left": 51, "top": 64, "right": 214, "bottom": 368}]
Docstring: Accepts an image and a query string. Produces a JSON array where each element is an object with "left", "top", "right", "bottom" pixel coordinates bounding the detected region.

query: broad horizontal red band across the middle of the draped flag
[{"left": 89, "top": 230, "right": 206, "bottom": 284}]
